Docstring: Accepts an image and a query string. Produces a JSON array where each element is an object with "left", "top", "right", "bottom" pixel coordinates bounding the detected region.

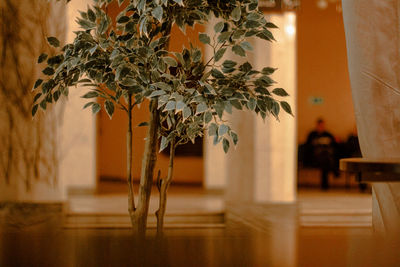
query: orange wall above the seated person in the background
[{"left": 297, "top": 0, "right": 355, "bottom": 142}]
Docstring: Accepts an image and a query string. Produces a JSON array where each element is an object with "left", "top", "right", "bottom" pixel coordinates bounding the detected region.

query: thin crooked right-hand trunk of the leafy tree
[{"left": 156, "top": 139, "right": 175, "bottom": 236}]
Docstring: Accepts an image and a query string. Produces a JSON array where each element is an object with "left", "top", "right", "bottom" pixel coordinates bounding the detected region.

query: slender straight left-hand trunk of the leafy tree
[{"left": 126, "top": 94, "right": 135, "bottom": 223}]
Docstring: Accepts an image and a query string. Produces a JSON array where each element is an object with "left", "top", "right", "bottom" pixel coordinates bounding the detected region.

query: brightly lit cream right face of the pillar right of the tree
[{"left": 253, "top": 12, "right": 297, "bottom": 202}]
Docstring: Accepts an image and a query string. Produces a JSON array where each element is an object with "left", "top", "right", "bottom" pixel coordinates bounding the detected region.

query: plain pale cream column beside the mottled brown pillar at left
[{"left": 60, "top": 0, "right": 96, "bottom": 194}]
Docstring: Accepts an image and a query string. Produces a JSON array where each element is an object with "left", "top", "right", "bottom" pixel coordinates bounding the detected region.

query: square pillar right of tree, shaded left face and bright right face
[{"left": 226, "top": 12, "right": 297, "bottom": 203}]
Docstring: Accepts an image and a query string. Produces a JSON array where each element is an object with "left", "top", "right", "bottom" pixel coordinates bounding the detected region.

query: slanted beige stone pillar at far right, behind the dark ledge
[{"left": 342, "top": 0, "right": 400, "bottom": 234}]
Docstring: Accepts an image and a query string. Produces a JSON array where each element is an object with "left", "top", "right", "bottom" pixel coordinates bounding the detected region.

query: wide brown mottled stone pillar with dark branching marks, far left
[{"left": 0, "top": 0, "right": 66, "bottom": 202}]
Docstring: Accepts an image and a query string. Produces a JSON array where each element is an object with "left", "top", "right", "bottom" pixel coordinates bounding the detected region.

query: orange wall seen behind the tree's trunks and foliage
[{"left": 97, "top": 5, "right": 204, "bottom": 184}]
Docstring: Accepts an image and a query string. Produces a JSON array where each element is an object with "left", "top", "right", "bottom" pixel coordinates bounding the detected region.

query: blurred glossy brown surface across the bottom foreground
[{"left": 0, "top": 228, "right": 400, "bottom": 267}]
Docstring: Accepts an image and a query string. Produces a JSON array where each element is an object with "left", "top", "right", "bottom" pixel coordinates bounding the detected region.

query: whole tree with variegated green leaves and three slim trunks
[{"left": 32, "top": 0, "right": 292, "bottom": 235}]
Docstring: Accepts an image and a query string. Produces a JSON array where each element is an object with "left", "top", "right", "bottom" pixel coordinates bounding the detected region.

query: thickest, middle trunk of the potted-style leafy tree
[{"left": 131, "top": 100, "right": 160, "bottom": 236}]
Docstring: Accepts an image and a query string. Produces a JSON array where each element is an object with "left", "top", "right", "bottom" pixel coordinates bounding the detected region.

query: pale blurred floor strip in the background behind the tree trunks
[{"left": 68, "top": 187, "right": 372, "bottom": 227}]
